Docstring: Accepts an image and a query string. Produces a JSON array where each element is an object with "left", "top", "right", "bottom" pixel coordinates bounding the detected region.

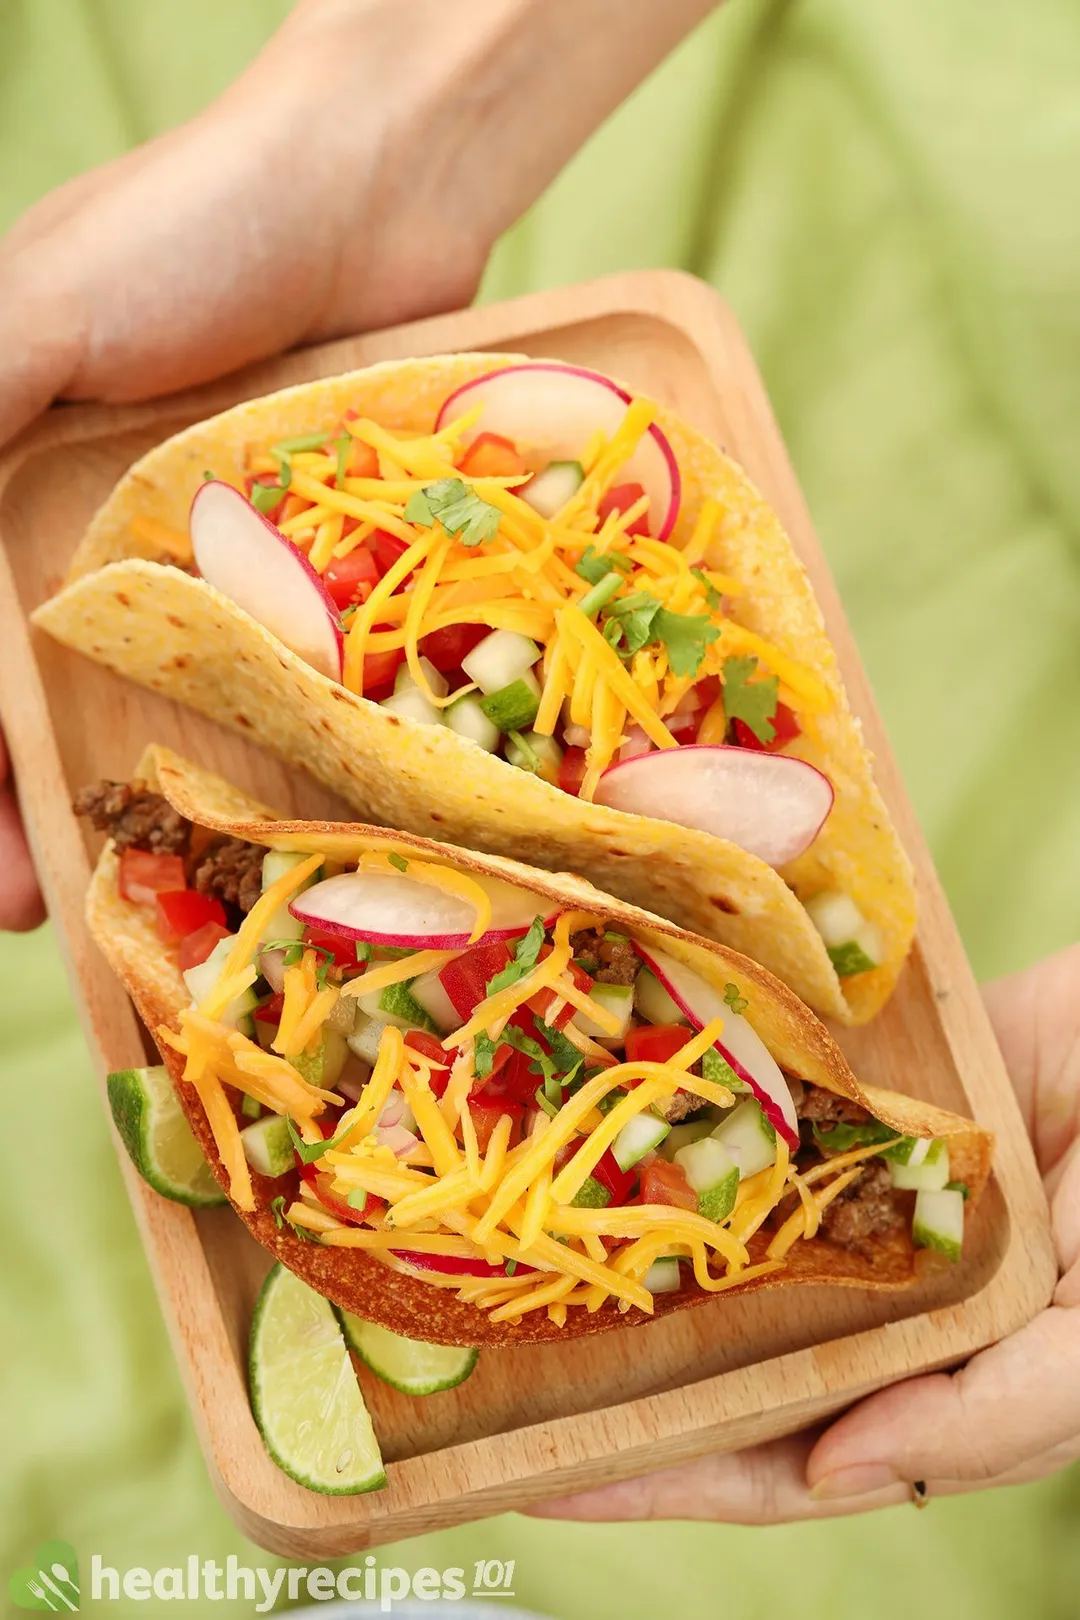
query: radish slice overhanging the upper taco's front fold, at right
[{"left": 594, "top": 744, "right": 834, "bottom": 867}]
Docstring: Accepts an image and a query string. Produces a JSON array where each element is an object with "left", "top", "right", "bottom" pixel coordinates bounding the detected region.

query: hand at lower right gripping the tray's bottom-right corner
[{"left": 533, "top": 946, "right": 1080, "bottom": 1524}]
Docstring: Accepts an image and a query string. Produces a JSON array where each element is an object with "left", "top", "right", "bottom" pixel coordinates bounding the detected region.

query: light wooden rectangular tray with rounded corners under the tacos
[{"left": 0, "top": 272, "right": 1056, "bottom": 1560}]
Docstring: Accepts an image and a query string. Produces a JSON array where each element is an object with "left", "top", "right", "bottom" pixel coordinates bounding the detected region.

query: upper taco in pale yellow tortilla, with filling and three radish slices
[{"left": 36, "top": 355, "right": 915, "bottom": 1022}]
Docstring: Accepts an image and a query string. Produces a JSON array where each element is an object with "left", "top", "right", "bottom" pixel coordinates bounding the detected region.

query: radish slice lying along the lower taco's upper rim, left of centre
[{"left": 290, "top": 872, "right": 557, "bottom": 951}]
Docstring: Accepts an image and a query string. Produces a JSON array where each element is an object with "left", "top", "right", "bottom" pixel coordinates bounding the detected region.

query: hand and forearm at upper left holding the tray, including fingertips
[{"left": 0, "top": 0, "right": 725, "bottom": 928}]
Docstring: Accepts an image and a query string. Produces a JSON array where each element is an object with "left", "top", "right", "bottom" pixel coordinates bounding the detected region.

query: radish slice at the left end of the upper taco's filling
[{"left": 189, "top": 478, "right": 345, "bottom": 680}]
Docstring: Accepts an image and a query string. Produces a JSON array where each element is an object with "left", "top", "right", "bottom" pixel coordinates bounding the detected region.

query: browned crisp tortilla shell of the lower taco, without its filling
[{"left": 86, "top": 747, "right": 993, "bottom": 1345}]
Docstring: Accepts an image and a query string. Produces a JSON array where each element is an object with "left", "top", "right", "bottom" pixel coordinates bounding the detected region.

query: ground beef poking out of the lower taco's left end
[{"left": 73, "top": 782, "right": 266, "bottom": 915}]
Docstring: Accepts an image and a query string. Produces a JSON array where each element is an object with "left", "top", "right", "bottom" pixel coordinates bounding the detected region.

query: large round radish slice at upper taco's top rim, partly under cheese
[{"left": 436, "top": 360, "right": 682, "bottom": 539}]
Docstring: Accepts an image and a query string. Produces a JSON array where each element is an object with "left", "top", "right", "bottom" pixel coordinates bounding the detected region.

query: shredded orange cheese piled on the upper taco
[{"left": 234, "top": 400, "right": 832, "bottom": 799}]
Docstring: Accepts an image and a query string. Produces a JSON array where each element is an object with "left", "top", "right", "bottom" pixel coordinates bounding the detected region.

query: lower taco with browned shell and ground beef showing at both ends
[{"left": 76, "top": 748, "right": 991, "bottom": 1345}]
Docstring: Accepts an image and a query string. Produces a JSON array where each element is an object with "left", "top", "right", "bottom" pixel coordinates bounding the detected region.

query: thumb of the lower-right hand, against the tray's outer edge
[{"left": 806, "top": 1306, "right": 1080, "bottom": 1502}]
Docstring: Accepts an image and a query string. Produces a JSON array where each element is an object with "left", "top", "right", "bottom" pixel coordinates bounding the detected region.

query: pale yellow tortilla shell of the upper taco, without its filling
[{"left": 44, "top": 355, "right": 915, "bottom": 1024}]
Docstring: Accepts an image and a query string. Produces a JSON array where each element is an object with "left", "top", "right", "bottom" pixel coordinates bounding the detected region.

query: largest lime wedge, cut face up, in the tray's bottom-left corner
[{"left": 248, "top": 1265, "right": 387, "bottom": 1497}]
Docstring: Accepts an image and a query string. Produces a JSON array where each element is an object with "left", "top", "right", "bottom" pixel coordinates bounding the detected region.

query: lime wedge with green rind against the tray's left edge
[{"left": 105, "top": 1066, "right": 225, "bottom": 1209}]
